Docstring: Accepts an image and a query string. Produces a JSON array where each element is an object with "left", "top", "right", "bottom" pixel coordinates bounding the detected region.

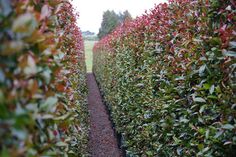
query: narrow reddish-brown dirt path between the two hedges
[{"left": 87, "top": 73, "right": 122, "bottom": 157}]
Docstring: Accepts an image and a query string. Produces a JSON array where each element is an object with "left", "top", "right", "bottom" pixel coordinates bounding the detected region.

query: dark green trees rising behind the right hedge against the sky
[{"left": 98, "top": 10, "right": 132, "bottom": 39}]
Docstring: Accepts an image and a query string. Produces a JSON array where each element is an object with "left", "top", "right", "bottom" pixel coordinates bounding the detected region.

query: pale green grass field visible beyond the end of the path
[{"left": 84, "top": 40, "right": 96, "bottom": 72}]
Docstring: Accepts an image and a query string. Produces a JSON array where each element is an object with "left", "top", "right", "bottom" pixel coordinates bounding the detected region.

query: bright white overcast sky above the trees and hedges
[{"left": 72, "top": 0, "right": 167, "bottom": 33}]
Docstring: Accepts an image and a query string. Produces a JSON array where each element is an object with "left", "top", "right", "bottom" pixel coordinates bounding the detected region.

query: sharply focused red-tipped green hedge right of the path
[{"left": 93, "top": 0, "right": 236, "bottom": 157}]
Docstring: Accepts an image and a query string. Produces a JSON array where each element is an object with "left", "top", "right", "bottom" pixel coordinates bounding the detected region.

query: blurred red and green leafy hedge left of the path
[{"left": 0, "top": 0, "right": 88, "bottom": 157}]
